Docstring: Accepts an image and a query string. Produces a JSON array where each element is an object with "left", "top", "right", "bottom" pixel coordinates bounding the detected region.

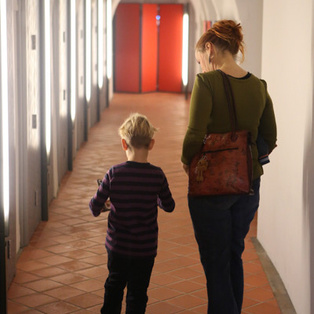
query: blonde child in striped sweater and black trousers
[{"left": 89, "top": 113, "right": 175, "bottom": 314}]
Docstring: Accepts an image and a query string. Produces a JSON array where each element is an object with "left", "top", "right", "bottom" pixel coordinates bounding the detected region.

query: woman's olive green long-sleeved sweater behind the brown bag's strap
[{"left": 181, "top": 71, "right": 277, "bottom": 179}]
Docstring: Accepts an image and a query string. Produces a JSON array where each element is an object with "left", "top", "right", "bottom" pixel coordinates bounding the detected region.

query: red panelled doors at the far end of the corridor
[{"left": 114, "top": 4, "right": 183, "bottom": 93}]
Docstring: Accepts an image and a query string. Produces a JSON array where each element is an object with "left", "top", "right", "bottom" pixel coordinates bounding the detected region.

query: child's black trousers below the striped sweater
[{"left": 100, "top": 251, "right": 155, "bottom": 314}]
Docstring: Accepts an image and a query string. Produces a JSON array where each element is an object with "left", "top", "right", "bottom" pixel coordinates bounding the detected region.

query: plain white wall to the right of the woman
[{"left": 258, "top": 0, "right": 314, "bottom": 314}]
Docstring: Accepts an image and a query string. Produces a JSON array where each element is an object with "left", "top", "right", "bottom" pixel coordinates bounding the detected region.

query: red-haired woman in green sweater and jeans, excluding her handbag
[{"left": 181, "top": 20, "right": 277, "bottom": 314}]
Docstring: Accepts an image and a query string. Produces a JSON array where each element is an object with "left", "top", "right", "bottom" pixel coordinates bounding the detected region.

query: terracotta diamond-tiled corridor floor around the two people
[{"left": 8, "top": 94, "right": 280, "bottom": 314}]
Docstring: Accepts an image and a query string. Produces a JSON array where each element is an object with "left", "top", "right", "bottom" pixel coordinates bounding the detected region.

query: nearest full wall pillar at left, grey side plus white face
[{"left": 10, "top": 0, "right": 41, "bottom": 249}]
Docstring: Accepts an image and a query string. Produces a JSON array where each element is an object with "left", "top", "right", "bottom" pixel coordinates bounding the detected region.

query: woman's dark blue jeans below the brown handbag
[{"left": 189, "top": 179, "right": 260, "bottom": 314}]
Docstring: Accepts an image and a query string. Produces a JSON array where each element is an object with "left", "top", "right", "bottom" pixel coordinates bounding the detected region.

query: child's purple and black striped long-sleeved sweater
[{"left": 89, "top": 161, "right": 175, "bottom": 257}]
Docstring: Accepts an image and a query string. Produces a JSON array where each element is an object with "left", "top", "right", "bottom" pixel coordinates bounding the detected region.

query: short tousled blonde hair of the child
[{"left": 119, "top": 113, "right": 157, "bottom": 148}]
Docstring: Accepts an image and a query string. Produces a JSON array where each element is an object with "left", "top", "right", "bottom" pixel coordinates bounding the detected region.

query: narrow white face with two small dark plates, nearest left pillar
[{"left": 23, "top": 0, "right": 41, "bottom": 244}]
